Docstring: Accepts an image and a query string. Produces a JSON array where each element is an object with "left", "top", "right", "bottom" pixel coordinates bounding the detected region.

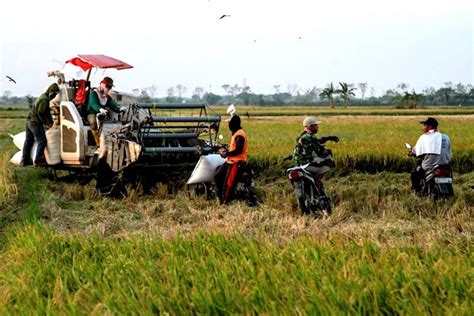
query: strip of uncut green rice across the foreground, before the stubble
[{"left": 0, "top": 225, "right": 473, "bottom": 315}]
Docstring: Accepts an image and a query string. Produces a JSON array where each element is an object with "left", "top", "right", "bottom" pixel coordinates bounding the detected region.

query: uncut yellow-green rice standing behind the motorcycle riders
[{"left": 227, "top": 112, "right": 474, "bottom": 173}]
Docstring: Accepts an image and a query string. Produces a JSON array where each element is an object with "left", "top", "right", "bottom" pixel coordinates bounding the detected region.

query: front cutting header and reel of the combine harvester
[{"left": 107, "top": 103, "right": 221, "bottom": 176}]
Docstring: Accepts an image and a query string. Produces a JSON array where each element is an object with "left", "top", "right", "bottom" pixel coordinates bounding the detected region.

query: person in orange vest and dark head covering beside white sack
[{"left": 215, "top": 115, "right": 248, "bottom": 204}]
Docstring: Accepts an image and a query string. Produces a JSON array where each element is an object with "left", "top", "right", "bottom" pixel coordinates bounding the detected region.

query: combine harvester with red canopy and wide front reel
[{"left": 12, "top": 55, "right": 221, "bottom": 194}]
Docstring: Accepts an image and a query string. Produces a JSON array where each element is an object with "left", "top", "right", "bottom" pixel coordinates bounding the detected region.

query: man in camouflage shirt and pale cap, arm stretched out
[{"left": 293, "top": 117, "right": 339, "bottom": 175}]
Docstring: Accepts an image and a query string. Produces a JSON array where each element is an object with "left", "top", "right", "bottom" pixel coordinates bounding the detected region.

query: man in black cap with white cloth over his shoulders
[{"left": 408, "top": 117, "right": 451, "bottom": 193}]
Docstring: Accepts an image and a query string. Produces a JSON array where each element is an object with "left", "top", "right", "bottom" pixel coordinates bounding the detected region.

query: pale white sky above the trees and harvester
[{"left": 0, "top": 0, "right": 474, "bottom": 96}]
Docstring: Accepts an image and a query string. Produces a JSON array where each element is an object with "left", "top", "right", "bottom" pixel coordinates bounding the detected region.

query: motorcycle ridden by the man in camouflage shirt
[{"left": 286, "top": 149, "right": 335, "bottom": 217}]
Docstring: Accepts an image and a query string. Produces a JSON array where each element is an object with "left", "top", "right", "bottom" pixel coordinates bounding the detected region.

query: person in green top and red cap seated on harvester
[{"left": 87, "top": 77, "right": 126, "bottom": 147}]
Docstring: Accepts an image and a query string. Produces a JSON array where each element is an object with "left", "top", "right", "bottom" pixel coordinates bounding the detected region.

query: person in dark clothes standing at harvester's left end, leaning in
[{"left": 20, "top": 83, "right": 59, "bottom": 166}]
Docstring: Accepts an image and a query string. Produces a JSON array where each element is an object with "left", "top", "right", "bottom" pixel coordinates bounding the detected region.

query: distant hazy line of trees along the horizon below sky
[{"left": 0, "top": 82, "right": 474, "bottom": 108}]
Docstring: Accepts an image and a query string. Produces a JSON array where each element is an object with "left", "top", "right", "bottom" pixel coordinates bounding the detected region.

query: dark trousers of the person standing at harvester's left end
[{"left": 22, "top": 118, "right": 46, "bottom": 164}]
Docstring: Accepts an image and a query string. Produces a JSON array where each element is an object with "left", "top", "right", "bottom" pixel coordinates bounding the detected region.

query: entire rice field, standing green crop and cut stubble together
[{"left": 0, "top": 107, "right": 474, "bottom": 315}]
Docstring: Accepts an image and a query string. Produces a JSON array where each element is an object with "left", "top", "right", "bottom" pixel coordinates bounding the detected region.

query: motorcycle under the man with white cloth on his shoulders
[{"left": 405, "top": 143, "right": 454, "bottom": 201}]
